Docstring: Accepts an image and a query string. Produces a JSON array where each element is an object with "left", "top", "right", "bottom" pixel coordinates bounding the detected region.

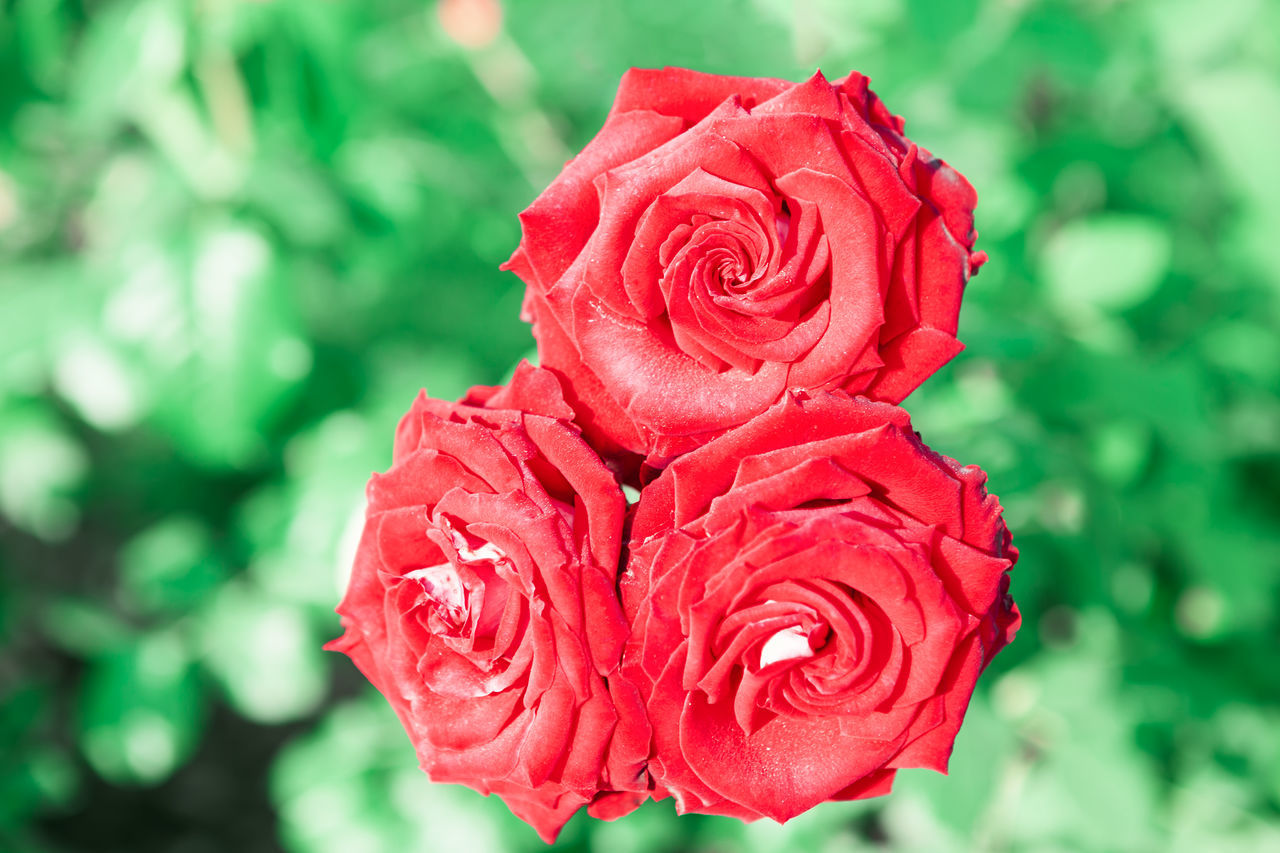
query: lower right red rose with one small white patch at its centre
[{"left": 621, "top": 392, "right": 1020, "bottom": 821}]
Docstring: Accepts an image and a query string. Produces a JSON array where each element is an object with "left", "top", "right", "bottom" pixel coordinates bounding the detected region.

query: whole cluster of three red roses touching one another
[{"left": 332, "top": 69, "right": 1019, "bottom": 841}]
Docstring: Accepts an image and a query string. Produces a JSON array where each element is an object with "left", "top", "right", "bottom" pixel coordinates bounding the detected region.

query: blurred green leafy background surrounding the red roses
[{"left": 0, "top": 0, "right": 1280, "bottom": 853}]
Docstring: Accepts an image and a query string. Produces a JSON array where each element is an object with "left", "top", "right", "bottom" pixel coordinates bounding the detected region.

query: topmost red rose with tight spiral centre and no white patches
[{"left": 507, "top": 68, "right": 984, "bottom": 469}]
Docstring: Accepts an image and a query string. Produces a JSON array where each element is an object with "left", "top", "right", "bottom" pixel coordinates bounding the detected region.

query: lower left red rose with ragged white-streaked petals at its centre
[{"left": 330, "top": 364, "right": 646, "bottom": 841}]
